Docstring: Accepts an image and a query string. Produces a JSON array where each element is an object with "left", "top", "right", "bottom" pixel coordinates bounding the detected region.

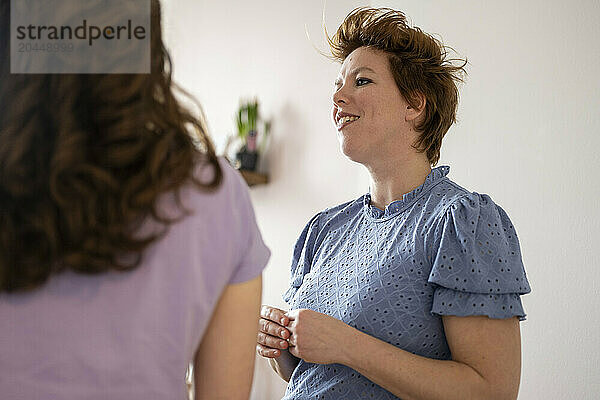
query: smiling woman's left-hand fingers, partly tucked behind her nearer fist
[{"left": 256, "top": 305, "right": 290, "bottom": 358}]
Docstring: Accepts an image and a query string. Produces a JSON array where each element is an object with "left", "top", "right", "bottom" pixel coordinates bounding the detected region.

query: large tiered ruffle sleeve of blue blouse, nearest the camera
[{"left": 429, "top": 193, "right": 531, "bottom": 321}]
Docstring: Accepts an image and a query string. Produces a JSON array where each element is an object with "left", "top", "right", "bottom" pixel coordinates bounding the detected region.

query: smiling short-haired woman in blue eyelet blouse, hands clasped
[{"left": 257, "top": 8, "right": 530, "bottom": 400}]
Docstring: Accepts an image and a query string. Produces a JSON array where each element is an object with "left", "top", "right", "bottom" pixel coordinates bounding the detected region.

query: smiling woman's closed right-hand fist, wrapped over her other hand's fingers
[{"left": 287, "top": 309, "right": 354, "bottom": 364}]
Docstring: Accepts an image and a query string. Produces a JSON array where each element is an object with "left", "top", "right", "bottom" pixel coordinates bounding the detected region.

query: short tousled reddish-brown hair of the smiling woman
[{"left": 327, "top": 7, "right": 467, "bottom": 165}]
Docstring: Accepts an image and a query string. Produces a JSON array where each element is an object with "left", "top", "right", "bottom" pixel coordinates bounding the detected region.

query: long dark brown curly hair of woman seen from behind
[{"left": 0, "top": 0, "right": 222, "bottom": 292}]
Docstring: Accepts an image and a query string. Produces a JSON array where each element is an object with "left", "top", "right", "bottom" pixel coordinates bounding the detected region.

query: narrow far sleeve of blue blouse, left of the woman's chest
[{"left": 283, "top": 213, "right": 321, "bottom": 304}]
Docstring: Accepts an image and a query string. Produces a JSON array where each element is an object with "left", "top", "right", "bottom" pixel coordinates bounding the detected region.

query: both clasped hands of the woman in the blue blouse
[{"left": 256, "top": 306, "right": 351, "bottom": 364}]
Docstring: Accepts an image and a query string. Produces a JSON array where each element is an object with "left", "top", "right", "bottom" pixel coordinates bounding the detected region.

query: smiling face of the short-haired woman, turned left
[{"left": 332, "top": 47, "right": 420, "bottom": 166}]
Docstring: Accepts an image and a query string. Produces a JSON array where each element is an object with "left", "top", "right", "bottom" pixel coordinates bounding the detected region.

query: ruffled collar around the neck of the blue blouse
[{"left": 363, "top": 165, "right": 450, "bottom": 220}]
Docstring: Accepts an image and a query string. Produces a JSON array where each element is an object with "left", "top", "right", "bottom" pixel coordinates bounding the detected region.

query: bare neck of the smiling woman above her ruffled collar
[{"left": 367, "top": 154, "right": 431, "bottom": 210}]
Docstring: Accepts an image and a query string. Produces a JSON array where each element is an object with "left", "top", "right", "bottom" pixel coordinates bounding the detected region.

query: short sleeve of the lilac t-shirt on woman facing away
[{"left": 224, "top": 166, "right": 271, "bottom": 284}]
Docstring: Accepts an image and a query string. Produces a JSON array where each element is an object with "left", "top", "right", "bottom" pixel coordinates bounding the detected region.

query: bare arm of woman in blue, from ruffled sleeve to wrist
[{"left": 340, "top": 316, "right": 521, "bottom": 400}]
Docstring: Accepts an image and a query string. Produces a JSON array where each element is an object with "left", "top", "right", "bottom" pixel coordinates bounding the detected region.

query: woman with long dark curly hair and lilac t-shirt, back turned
[{"left": 0, "top": 0, "right": 269, "bottom": 400}]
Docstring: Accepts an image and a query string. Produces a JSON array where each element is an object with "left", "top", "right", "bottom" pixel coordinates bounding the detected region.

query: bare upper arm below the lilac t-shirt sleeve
[{"left": 194, "top": 276, "right": 262, "bottom": 400}]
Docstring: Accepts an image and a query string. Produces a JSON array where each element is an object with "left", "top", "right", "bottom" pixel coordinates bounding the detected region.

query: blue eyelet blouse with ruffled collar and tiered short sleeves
[{"left": 283, "top": 166, "right": 530, "bottom": 400}]
